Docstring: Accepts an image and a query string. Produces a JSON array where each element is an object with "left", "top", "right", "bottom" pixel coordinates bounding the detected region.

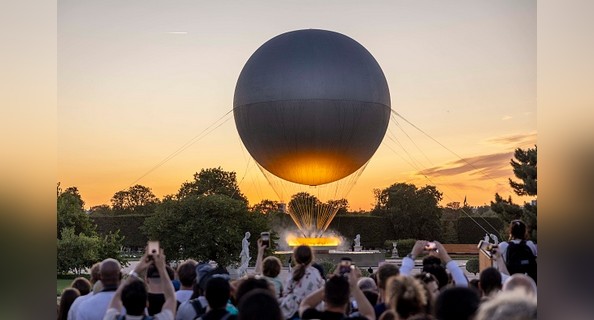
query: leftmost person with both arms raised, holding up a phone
[{"left": 102, "top": 249, "right": 177, "bottom": 320}]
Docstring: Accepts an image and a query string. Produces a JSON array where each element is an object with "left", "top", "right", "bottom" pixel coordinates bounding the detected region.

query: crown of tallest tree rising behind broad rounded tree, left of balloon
[{"left": 177, "top": 167, "right": 248, "bottom": 203}]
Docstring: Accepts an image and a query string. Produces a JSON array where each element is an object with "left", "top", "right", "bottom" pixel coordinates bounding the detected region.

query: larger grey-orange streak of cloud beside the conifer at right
[{"left": 417, "top": 152, "right": 513, "bottom": 179}]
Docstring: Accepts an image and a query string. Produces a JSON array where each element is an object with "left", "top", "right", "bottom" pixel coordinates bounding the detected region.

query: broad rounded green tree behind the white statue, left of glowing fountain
[{"left": 142, "top": 194, "right": 269, "bottom": 266}]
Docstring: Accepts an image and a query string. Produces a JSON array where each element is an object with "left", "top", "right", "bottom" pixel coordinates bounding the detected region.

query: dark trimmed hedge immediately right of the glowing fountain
[{"left": 328, "top": 214, "right": 400, "bottom": 249}]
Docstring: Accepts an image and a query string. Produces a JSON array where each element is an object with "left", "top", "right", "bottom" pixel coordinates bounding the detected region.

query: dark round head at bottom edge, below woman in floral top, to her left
[{"left": 238, "top": 289, "right": 284, "bottom": 320}]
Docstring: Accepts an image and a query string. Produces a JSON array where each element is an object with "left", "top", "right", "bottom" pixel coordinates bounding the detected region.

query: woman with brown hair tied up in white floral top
[{"left": 279, "top": 245, "right": 324, "bottom": 319}]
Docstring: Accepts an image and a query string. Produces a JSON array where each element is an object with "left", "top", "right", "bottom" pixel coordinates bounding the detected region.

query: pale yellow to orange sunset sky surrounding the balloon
[{"left": 57, "top": 0, "right": 537, "bottom": 210}]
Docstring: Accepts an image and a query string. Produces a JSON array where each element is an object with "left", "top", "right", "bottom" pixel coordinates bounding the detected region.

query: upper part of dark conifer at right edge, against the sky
[{"left": 509, "top": 146, "right": 537, "bottom": 196}]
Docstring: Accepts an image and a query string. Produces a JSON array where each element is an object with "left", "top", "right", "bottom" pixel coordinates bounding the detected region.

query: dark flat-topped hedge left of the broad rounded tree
[{"left": 91, "top": 214, "right": 149, "bottom": 248}]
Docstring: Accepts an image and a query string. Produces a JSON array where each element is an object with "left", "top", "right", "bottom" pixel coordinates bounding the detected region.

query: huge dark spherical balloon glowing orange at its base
[{"left": 233, "top": 29, "right": 391, "bottom": 185}]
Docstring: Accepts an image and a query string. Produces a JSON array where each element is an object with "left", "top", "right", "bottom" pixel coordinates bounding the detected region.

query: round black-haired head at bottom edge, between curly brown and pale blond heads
[{"left": 435, "top": 287, "right": 480, "bottom": 320}]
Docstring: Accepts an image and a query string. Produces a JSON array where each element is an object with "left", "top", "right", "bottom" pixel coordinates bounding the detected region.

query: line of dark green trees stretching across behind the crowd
[{"left": 57, "top": 146, "right": 537, "bottom": 273}]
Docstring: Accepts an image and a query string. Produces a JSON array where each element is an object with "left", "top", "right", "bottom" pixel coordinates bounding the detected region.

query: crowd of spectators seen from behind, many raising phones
[{"left": 58, "top": 220, "right": 537, "bottom": 320}]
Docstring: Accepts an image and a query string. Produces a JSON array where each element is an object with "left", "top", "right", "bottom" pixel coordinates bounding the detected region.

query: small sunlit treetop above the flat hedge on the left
[{"left": 111, "top": 184, "right": 159, "bottom": 214}]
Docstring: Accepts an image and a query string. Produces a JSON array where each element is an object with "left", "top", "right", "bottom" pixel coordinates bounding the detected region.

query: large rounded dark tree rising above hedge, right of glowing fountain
[{"left": 373, "top": 183, "right": 442, "bottom": 240}]
